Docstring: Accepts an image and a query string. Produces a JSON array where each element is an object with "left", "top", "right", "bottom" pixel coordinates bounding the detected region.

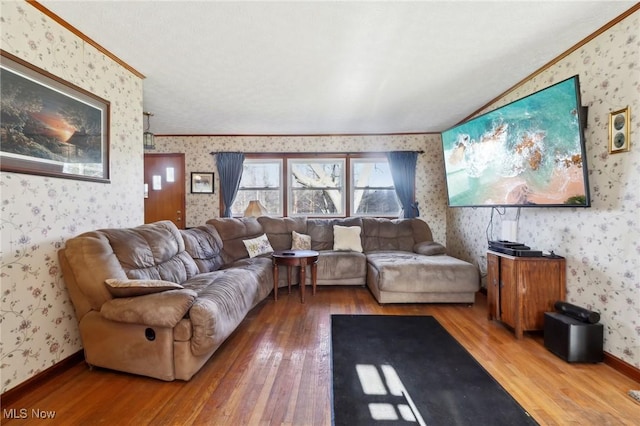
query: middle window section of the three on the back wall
[{"left": 287, "top": 158, "right": 345, "bottom": 216}]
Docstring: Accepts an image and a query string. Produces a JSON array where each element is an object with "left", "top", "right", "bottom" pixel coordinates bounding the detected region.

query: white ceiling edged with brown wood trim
[{"left": 40, "top": 0, "right": 634, "bottom": 135}]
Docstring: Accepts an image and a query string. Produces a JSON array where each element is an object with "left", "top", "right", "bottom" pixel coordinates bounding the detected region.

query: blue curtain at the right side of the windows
[{"left": 387, "top": 151, "right": 420, "bottom": 218}]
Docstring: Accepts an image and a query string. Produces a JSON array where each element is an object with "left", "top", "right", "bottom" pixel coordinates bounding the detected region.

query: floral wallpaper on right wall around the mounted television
[{"left": 447, "top": 12, "right": 640, "bottom": 368}]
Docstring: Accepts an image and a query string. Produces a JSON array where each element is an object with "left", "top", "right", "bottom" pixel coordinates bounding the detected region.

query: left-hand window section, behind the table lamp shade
[{"left": 231, "top": 159, "right": 284, "bottom": 216}]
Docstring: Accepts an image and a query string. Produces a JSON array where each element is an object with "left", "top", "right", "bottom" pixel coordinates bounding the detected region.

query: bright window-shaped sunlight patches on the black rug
[{"left": 356, "top": 364, "right": 426, "bottom": 426}]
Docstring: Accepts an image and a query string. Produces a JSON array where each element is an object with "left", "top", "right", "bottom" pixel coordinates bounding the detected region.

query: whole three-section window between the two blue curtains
[{"left": 231, "top": 152, "right": 401, "bottom": 217}]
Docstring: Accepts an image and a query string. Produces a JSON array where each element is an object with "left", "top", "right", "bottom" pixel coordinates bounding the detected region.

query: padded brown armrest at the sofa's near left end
[{"left": 100, "top": 289, "right": 198, "bottom": 328}]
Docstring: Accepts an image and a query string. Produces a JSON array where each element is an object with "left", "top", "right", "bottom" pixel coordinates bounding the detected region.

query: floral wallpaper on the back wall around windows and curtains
[{"left": 148, "top": 134, "right": 447, "bottom": 243}]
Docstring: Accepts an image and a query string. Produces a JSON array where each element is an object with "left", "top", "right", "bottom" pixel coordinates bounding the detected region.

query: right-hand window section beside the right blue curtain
[{"left": 350, "top": 158, "right": 401, "bottom": 216}]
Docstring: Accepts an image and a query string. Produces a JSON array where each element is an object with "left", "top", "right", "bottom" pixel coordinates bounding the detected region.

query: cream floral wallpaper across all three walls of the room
[{"left": 0, "top": 0, "right": 640, "bottom": 392}]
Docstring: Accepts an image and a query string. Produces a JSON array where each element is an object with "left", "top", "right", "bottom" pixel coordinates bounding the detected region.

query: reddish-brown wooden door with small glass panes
[{"left": 144, "top": 154, "right": 186, "bottom": 229}]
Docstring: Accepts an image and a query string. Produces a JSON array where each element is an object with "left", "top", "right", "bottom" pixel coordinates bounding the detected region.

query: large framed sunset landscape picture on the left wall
[{"left": 0, "top": 51, "right": 110, "bottom": 183}]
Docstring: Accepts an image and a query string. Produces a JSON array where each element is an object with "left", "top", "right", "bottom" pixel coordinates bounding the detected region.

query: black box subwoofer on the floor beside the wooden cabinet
[{"left": 544, "top": 312, "right": 604, "bottom": 362}]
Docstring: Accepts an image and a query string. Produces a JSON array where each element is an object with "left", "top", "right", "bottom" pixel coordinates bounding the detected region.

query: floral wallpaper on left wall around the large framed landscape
[{"left": 0, "top": 1, "right": 144, "bottom": 392}]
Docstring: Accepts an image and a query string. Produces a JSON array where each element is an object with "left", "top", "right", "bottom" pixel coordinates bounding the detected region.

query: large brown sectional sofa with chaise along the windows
[{"left": 59, "top": 217, "right": 479, "bottom": 380}]
